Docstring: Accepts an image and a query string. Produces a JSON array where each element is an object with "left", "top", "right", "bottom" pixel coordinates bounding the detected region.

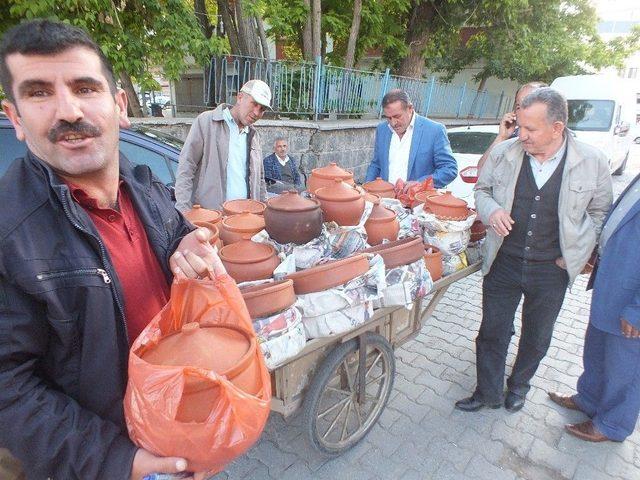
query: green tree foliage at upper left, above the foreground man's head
[{"left": 0, "top": 0, "right": 227, "bottom": 90}]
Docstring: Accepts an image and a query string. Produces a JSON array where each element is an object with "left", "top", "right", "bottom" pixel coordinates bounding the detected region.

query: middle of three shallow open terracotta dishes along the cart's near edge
[{"left": 285, "top": 255, "right": 369, "bottom": 295}]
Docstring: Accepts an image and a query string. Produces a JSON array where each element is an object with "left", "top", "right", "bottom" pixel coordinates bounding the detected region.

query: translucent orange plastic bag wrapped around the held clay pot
[{"left": 124, "top": 275, "right": 271, "bottom": 473}]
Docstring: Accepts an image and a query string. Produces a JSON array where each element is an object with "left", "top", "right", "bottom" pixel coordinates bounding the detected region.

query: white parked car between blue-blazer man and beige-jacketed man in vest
[{"left": 447, "top": 125, "right": 499, "bottom": 207}]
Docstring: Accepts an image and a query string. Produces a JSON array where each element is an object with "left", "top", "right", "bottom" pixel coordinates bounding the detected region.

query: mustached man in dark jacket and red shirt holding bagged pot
[{"left": 0, "top": 20, "right": 224, "bottom": 480}]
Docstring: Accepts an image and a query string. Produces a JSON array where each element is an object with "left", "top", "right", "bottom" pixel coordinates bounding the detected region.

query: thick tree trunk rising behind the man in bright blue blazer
[{"left": 399, "top": 0, "right": 444, "bottom": 78}]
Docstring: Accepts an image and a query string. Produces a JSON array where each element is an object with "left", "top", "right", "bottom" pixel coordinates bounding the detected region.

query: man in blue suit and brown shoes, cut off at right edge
[{"left": 549, "top": 175, "right": 640, "bottom": 442}]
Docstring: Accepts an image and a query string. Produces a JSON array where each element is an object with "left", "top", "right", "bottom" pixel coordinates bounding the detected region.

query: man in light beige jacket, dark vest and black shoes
[{"left": 456, "top": 88, "right": 612, "bottom": 412}]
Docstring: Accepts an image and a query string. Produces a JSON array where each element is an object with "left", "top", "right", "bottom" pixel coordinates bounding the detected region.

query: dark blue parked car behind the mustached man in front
[{"left": 0, "top": 115, "right": 183, "bottom": 188}]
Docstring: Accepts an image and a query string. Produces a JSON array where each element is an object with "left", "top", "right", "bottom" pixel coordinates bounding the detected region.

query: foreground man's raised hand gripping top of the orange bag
[{"left": 169, "top": 228, "right": 227, "bottom": 278}]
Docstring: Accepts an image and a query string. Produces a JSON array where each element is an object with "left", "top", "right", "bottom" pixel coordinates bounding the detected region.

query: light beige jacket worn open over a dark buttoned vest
[{"left": 475, "top": 132, "right": 613, "bottom": 283}]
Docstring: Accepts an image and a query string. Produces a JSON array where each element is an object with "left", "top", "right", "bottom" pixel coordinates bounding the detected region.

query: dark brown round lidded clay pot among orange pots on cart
[{"left": 264, "top": 190, "right": 322, "bottom": 245}]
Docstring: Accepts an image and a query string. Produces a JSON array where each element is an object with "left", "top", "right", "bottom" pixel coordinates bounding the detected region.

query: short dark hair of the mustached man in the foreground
[{"left": 0, "top": 19, "right": 117, "bottom": 103}]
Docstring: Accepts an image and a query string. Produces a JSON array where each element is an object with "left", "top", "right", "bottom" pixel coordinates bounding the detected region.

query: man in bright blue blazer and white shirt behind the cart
[{"left": 366, "top": 90, "right": 458, "bottom": 188}]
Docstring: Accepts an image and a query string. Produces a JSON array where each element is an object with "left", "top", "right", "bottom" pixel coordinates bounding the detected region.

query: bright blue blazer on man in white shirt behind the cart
[{"left": 366, "top": 113, "right": 458, "bottom": 188}]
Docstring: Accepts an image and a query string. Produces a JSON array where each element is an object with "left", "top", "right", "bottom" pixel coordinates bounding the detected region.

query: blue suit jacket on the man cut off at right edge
[{"left": 589, "top": 175, "right": 640, "bottom": 335}]
